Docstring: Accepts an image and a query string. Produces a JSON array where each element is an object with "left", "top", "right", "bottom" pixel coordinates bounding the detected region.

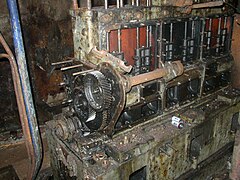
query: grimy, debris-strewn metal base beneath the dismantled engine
[{"left": 48, "top": 87, "right": 240, "bottom": 179}]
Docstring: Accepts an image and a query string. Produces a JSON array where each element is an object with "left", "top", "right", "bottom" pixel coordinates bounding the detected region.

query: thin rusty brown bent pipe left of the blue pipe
[{"left": 0, "top": 33, "right": 35, "bottom": 179}]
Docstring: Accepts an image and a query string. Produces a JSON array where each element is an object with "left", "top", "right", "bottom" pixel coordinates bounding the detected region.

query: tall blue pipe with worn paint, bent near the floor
[{"left": 7, "top": 0, "right": 42, "bottom": 179}]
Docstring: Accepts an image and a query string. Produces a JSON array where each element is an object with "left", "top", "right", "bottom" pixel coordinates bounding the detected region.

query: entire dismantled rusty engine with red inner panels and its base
[{"left": 48, "top": 0, "right": 240, "bottom": 179}]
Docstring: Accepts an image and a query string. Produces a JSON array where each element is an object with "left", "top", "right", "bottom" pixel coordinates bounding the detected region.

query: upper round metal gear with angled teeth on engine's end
[{"left": 83, "top": 71, "right": 112, "bottom": 112}]
